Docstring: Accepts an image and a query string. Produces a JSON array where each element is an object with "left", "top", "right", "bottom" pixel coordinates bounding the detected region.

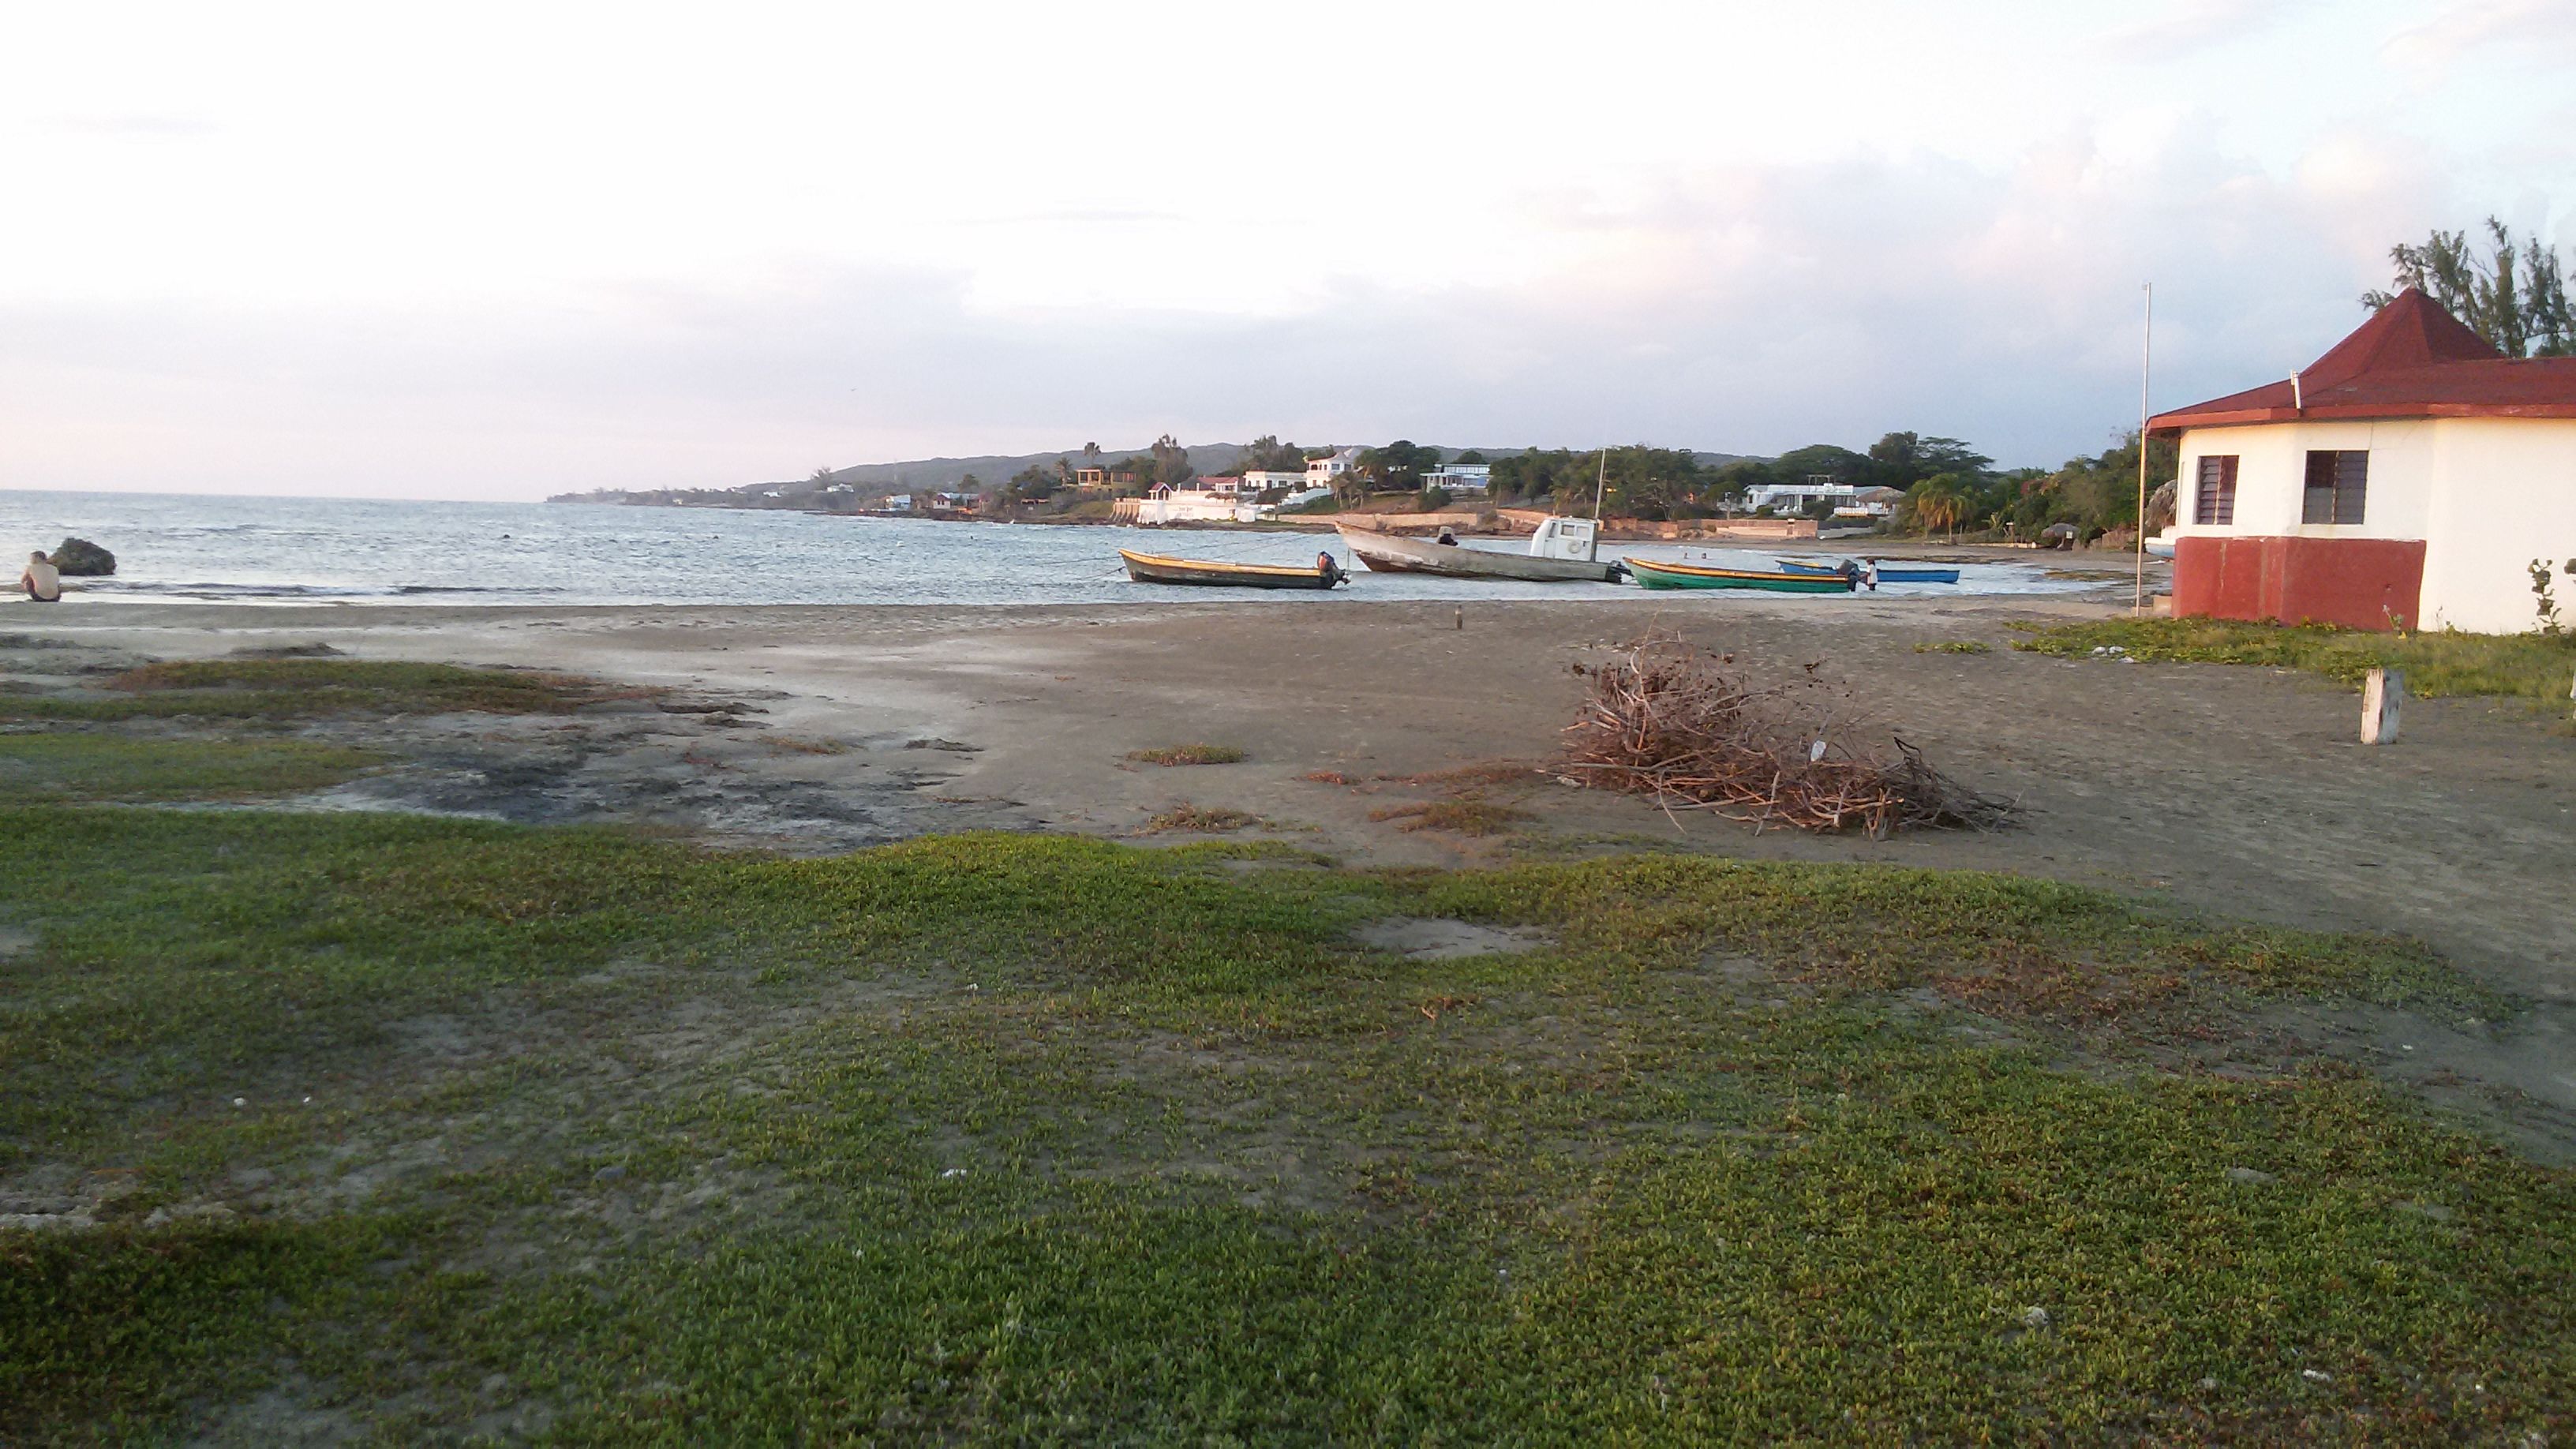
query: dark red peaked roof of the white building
[{"left": 2148, "top": 286, "right": 2576, "bottom": 436}]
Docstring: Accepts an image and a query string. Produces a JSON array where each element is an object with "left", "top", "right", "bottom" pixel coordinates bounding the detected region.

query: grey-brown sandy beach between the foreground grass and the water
[{"left": 15, "top": 587, "right": 2576, "bottom": 1001}]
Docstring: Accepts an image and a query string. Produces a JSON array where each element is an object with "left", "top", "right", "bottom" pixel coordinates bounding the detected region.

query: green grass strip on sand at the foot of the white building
[{"left": 2009, "top": 619, "right": 2576, "bottom": 704}]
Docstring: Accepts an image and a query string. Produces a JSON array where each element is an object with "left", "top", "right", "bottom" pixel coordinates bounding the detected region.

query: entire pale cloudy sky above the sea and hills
[{"left": 0, "top": 0, "right": 2576, "bottom": 498}]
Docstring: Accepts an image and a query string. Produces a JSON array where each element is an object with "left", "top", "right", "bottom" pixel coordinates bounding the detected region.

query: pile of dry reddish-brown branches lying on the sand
[{"left": 1567, "top": 635, "right": 2014, "bottom": 835}]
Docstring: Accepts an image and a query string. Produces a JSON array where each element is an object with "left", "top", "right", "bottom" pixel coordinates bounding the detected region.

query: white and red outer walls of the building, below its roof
[{"left": 2172, "top": 417, "right": 2576, "bottom": 631}]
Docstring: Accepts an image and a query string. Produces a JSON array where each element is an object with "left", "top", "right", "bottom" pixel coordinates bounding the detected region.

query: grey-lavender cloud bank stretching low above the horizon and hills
[{"left": 0, "top": 115, "right": 2445, "bottom": 498}]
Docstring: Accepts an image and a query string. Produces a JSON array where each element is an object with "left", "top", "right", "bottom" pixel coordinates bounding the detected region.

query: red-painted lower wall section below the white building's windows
[{"left": 2174, "top": 537, "right": 2424, "bottom": 629}]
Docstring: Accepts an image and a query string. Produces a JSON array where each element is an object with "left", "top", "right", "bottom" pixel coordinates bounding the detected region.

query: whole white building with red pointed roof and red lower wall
[{"left": 2148, "top": 289, "right": 2576, "bottom": 635}]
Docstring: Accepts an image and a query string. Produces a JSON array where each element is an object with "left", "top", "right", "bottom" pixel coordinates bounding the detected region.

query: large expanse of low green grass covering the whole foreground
[{"left": 0, "top": 644, "right": 2576, "bottom": 1443}]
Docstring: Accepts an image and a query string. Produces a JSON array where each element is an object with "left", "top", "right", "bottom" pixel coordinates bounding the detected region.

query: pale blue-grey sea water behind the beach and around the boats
[{"left": 0, "top": 490, "right": 2089, "bottom": 606}]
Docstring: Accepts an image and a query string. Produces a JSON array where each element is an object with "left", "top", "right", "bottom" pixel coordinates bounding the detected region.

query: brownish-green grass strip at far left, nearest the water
[{"left": 0, "top": 657, "right": 650, "bottom": 722}]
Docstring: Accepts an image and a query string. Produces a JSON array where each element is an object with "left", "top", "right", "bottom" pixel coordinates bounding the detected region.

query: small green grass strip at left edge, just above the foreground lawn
[{"left": 0, "top": 732, "right": 384, "bottom": 804}]
